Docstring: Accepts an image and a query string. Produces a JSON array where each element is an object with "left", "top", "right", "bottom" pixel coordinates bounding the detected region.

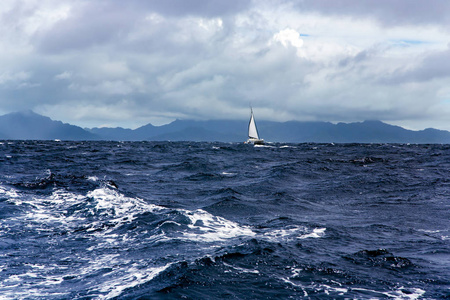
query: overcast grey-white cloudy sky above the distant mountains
[{"left": 0, "top": 0, "right": 450, "bottom": 130}]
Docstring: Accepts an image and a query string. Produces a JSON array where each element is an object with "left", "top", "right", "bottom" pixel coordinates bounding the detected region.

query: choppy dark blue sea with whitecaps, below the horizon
[{"left": 0, "top": 141, "right": 450, "bottom": 299}]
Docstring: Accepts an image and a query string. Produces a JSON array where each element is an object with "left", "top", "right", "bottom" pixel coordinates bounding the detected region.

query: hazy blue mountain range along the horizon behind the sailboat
[{"left": 0, "top": 111, "right": 450, "bottom": 144}]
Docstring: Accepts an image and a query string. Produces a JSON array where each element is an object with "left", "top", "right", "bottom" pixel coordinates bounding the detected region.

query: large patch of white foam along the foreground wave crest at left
[{"left": 7, "top": 187, "right": 255, "bottom": 247}]
